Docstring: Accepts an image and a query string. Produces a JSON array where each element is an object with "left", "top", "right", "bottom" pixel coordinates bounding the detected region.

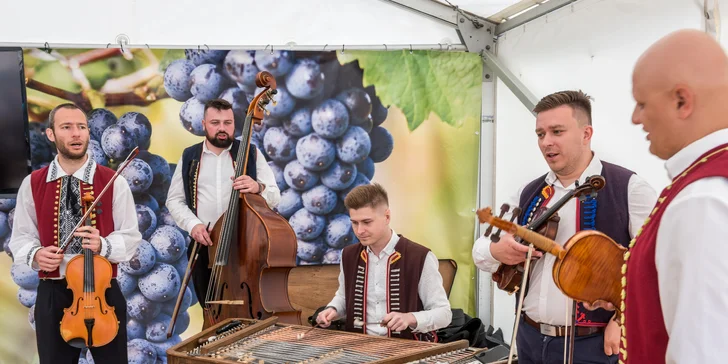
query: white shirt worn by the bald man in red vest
[{"left": 656, "top": 129, "right": 728, "bottom": 364}]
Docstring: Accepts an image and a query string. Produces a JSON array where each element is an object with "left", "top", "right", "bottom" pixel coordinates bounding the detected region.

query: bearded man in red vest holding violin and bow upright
[{"left": 10, "top": 104, "right": 142, "bottom": 364}]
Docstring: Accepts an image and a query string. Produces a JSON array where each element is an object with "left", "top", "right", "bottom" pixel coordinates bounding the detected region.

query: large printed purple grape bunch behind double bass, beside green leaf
[{"left": 164, "top": 49, "right": 394, "bottom": 265}]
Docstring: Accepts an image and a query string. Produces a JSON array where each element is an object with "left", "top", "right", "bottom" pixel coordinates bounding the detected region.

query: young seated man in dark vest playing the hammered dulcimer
[{"left": 316, "top": 183, "right": 452, "bottom": 341}]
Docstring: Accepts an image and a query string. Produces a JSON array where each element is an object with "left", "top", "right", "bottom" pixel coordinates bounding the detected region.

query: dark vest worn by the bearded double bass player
[{"left": 177, "top": 140, "right": 258, "bottom": 214}]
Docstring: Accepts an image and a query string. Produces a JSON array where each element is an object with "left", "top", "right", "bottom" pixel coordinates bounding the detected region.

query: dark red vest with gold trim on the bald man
[{"left": 619, "top": 144, "right": 728, "bottom": 364}]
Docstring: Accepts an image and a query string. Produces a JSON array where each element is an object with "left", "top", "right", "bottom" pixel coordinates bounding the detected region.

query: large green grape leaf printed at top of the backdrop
[{"left": 338, "top": 50, "right": 483, "bottom": 131}]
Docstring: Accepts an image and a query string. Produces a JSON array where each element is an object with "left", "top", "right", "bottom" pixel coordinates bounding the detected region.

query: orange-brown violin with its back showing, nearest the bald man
[{"left": 477, "top": 207, "right": 627, "bottom": 318}]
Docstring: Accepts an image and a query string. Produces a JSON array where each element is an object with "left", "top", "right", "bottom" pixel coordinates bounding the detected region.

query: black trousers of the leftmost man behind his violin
[{"left": 35, "top": 279, "right": 128, "bottom": 364}]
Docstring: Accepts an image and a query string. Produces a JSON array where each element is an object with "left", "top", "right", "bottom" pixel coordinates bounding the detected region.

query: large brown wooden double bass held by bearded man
[{"left": 203, "top": 71, "right": 301, "bottom": 328}]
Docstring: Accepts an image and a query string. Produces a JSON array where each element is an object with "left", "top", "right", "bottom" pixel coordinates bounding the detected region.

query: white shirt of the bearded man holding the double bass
[{"left": 166, "top": 141, "right": 281, "bottom": 234}]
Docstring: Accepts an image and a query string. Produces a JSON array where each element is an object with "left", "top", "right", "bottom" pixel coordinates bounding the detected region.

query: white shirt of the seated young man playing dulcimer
[{"left": 328, "top": 230, "right": 452, "bottom": 336}]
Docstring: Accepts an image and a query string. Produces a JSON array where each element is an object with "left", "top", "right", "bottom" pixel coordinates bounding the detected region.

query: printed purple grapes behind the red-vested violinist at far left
[{"left": 8, "top": 109, "right": 189, "bottom": 364}]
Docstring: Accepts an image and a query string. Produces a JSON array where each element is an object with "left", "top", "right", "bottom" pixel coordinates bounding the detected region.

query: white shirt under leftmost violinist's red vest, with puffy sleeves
[{"left": 10, "top": 156, "right": 142, "bottom": 279}]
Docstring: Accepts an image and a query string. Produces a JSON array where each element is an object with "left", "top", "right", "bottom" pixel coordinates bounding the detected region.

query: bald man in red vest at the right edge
[{"left": 604, "top": 30, "right": 728, "bottom": 363}]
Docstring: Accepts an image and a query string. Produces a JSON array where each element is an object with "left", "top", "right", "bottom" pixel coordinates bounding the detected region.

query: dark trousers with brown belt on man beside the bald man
[{"left": 516, "top": 318, "right": 619, "bottom": 364}]
